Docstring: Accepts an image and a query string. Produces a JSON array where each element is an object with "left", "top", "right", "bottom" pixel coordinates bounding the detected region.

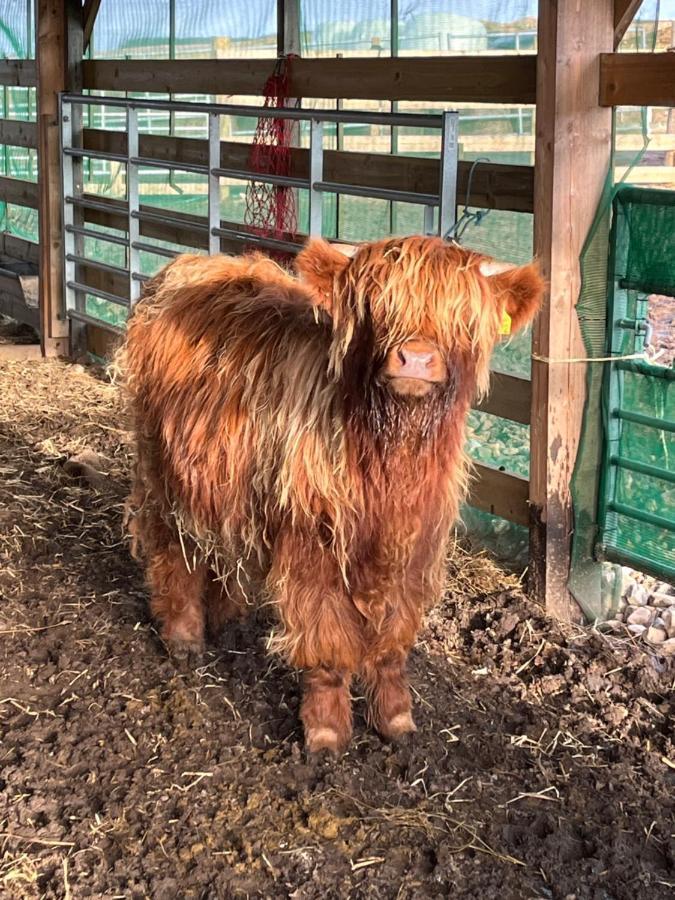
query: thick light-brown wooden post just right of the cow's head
[{"left": 530, "top": 0, "right": 614, "bottom": 620}]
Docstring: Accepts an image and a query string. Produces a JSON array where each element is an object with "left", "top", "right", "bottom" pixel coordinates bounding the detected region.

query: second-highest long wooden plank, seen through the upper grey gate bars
[{"left": 83, "top": 128, "right": 534, "bottom": 212}]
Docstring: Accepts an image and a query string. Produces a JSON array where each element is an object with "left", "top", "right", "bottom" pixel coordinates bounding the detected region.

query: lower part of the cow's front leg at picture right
[{"left": 361, "top": 646, "right": 416, "bottom": 740}]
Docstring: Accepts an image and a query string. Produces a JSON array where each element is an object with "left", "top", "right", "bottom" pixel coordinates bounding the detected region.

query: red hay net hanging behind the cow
[{"left": 244, "top": 57, "right": 298, "bottom": 263}]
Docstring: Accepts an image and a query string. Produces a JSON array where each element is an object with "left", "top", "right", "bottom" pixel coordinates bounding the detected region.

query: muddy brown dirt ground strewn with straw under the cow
[{"left": 0, "top": 362, "right": 675, "bottom": 900}]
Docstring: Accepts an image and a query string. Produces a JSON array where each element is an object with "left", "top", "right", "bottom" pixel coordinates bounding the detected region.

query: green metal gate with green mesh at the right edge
[{"left": 598, "top": 187, "right": 675, "bottom": 579}]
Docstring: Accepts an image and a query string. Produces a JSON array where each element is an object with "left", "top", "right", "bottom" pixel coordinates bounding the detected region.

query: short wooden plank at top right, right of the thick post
[{"left": 600, "top": 52, "right": 675, "bottom": 106}]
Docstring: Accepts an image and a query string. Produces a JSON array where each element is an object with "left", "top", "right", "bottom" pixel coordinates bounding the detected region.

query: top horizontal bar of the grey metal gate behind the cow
[{"left": 63, "top": 94, "right": 443, "bottom": 131}]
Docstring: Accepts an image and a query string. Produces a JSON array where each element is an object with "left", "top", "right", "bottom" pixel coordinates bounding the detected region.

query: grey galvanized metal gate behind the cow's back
[{"left": 61, "top": 94, "right": 458, "bottom": 331}]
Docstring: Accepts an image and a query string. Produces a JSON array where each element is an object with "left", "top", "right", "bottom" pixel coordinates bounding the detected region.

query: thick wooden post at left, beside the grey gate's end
[{"left": 36, "top": 0, "right": 83, "bottom": 356}]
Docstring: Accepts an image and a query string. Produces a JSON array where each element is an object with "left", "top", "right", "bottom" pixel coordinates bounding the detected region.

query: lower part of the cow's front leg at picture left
[{"left": 300, "top": 666, "right": 352, "bottom": 755}]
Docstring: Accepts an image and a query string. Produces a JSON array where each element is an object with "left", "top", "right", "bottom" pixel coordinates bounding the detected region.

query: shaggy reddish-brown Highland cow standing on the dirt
[{"left": 119, "top": 237, "right": 542, "bottom": 752}]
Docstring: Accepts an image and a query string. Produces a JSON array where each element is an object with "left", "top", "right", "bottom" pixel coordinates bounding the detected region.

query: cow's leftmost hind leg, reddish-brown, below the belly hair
[{"left": 148, "top": 542, "right": 206, "bottom": 650}]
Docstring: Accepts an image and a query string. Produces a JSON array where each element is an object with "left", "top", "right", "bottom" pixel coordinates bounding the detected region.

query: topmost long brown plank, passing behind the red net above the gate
[{"left": 83, "top": 56, "right": 536, "bottom": 103}]
